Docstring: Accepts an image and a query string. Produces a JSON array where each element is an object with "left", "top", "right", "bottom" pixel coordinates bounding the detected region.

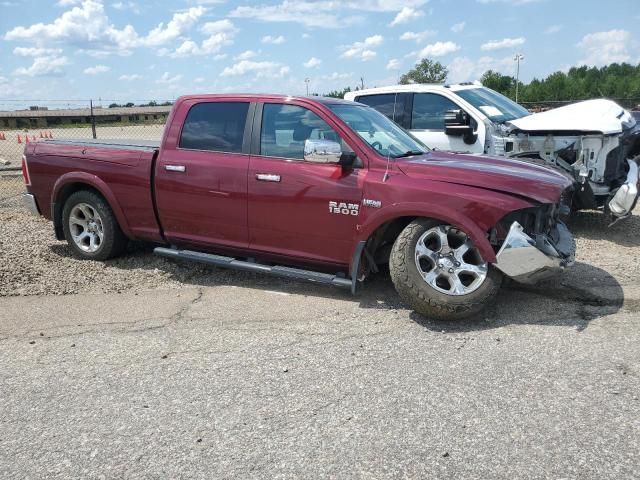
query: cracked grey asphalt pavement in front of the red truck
[{"left": 0, "top": 276, "right": 640, "bottom": 479}]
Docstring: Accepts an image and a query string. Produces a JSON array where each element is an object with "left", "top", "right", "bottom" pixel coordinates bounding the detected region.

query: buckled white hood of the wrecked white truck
[{"left": 507, "top": 99, "right": 636, "bottom": 135}]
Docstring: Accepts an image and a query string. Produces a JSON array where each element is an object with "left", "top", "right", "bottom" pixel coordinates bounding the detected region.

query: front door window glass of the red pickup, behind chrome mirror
[{"left": 260, "top": 103, "right": 340, "bottom": 160}]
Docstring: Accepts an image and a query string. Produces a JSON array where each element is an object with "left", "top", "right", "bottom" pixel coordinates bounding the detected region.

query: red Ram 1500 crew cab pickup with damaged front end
[{"left": 23, "top": 95, "right": 574, "bottom": 319}]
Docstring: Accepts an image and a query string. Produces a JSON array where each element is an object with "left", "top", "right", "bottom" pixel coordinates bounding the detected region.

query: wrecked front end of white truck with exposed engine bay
[{"left": 492, "top": 100, "right": 640, "bottom": 219}]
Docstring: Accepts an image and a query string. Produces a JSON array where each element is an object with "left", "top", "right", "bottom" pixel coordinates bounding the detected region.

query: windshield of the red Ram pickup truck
[{"left": 329, "top": 105, "right": 429, "bottom": 158}]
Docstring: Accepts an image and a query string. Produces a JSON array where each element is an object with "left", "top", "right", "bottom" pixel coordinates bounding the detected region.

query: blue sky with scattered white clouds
[{"left": 0, "top": 0, "right": 640, "bottom": 110}]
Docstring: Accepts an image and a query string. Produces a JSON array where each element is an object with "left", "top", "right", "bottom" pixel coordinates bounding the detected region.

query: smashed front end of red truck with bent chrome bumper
[{"left": 491, "top": 205, "right": 575, "bottom": 284}]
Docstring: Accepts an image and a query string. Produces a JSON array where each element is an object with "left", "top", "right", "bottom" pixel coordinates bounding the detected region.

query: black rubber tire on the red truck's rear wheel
[{"left": 62, "top": 190, "right": 128, "bottom": 261}]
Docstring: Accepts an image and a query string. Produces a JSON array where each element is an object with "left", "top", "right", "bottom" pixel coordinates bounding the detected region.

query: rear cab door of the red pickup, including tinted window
[{"left": 155, "top": 99, "right": 253, "bottom": 248}]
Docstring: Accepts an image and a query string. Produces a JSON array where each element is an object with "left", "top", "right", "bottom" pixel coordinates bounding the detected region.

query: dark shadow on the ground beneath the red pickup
[{"left": 51, "top": 244, "right": 624, "bottom": 333}]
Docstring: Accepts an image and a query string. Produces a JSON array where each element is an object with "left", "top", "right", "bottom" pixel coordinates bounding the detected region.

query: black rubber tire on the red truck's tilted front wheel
[{"left": 389, "top": 219, "right": 502, "bottom": 320}]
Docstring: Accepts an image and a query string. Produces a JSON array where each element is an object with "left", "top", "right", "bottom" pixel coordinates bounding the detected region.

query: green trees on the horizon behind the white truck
[{"left": 327, "top": 58, "right": 640, "bottom": 106}]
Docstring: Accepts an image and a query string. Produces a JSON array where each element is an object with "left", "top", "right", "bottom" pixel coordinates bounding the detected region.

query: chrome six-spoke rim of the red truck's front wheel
[{"left": 415, "top": 225, "right": 488, "bottom": 295}]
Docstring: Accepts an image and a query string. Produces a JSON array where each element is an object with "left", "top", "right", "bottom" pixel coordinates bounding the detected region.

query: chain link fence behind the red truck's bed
[{"left": 0, "top": 100, "right": 171, "bottom": 208}]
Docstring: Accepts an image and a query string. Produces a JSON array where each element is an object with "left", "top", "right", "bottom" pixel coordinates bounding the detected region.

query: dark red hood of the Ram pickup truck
[{"left": 398, "top": 151, "right": 572, "bottom": 203}]
